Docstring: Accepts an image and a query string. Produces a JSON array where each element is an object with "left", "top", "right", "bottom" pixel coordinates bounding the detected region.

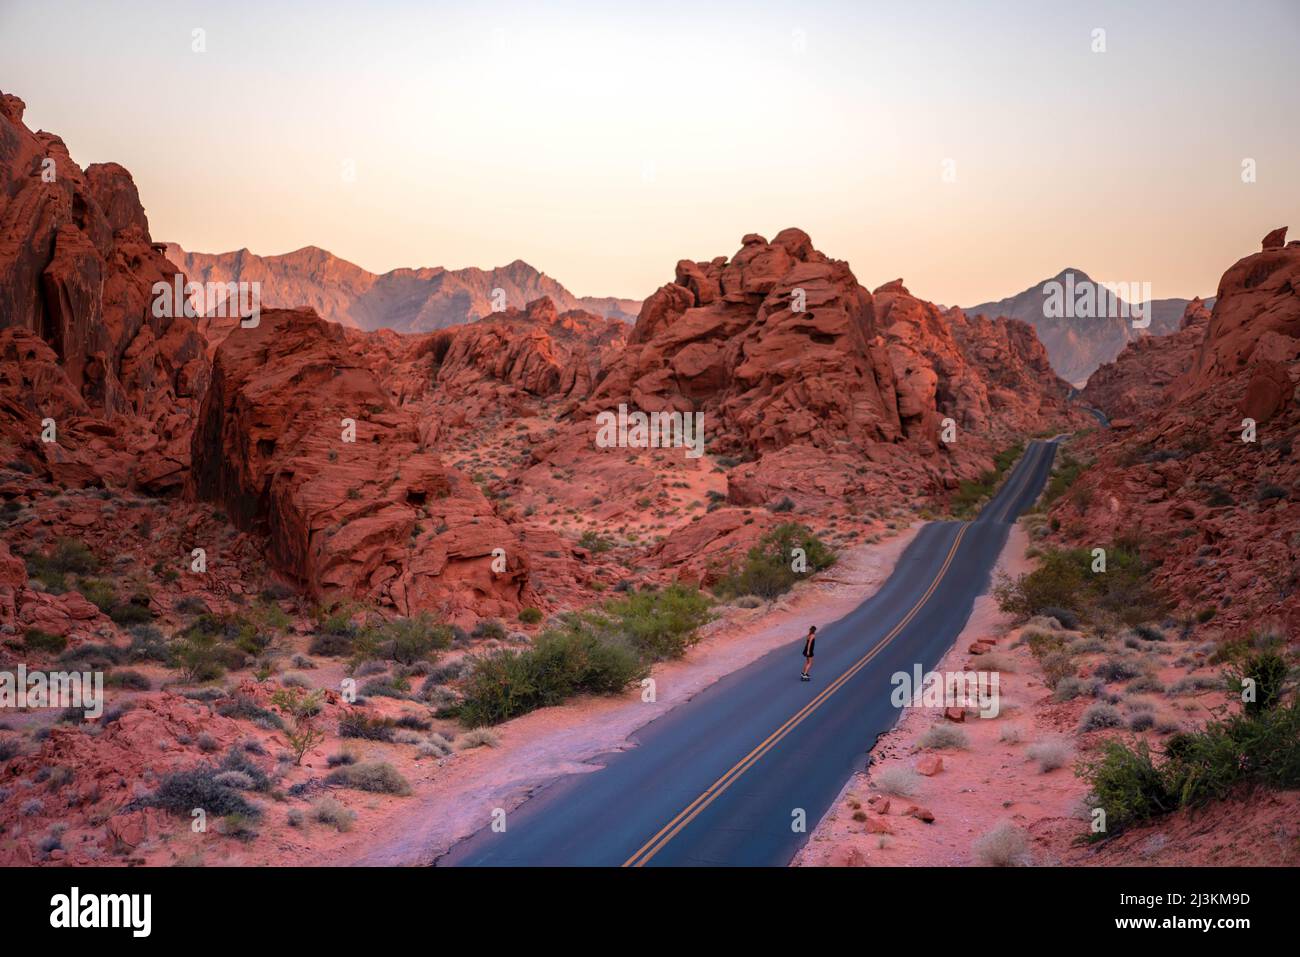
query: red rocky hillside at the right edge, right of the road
[{"left": 1053, "top": 227, "right": 1300, "bottom": 640}]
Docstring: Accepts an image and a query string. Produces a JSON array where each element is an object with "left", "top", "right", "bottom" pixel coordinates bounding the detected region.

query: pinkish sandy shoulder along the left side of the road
[{"left": 340, "top": 523, "right": 922, "bottom": 865}]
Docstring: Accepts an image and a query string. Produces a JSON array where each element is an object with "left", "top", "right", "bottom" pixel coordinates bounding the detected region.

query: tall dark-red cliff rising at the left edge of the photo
[{"left": 0, "top": 87, "right": 207, "bottom": 492}]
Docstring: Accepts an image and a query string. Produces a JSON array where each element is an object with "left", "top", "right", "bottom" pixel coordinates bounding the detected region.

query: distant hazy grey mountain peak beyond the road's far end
[{"left": 963, "top": 269, "right": 1214, "bottom": 387}]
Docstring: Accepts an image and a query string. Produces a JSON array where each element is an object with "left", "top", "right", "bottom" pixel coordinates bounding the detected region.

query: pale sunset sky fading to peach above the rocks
[{"left": 0, "top": 0, "right": 1300, "bottom": 306}]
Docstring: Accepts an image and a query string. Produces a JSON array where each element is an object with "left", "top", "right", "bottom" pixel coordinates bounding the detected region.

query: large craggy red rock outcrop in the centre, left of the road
[{"left": 584, "top": 229, "right": 1069, "bottom": 488}]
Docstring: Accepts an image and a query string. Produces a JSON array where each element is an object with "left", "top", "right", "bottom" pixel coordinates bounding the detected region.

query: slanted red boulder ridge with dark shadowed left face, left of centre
[{"left": 192, "top": 309, "right": 528, "bottom": 620}]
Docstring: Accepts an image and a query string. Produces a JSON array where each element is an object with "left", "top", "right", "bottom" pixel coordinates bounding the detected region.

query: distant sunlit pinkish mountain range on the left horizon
[{"left": 166, "top": 243, "right": 641, "bottom": 333}]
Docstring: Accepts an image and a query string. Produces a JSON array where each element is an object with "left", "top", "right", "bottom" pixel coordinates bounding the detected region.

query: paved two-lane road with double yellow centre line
[{"left": 437, "top": 442, "right": 1056, "bottom": 866}]
